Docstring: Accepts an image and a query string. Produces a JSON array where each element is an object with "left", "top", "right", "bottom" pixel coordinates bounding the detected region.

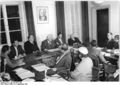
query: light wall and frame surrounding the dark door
[{"left": 89, "top": 1, "right": 120, "bottom": 40}]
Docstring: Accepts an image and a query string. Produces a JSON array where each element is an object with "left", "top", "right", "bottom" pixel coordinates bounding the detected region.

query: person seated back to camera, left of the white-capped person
[{"left": 53, "top": 44, "right": 72, "bottom": 78}]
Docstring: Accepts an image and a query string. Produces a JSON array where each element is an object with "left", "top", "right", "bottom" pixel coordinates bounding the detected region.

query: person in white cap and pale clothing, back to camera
[{"left": 71, "top": 47, "right": 93, "bottom": 81}]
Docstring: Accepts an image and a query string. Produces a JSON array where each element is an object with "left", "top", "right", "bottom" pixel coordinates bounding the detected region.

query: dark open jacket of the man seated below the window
[{"left": 9, "top": 45, "right": 25, "bottom": 59}]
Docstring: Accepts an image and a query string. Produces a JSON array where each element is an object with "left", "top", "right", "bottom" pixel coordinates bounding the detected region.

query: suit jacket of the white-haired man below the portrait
[{"left": 41, "top": 39, "right": 57, "bottom": 51}]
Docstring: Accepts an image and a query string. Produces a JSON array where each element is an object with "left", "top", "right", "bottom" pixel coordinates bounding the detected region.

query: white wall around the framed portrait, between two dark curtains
[{"left": 32, "top": 0, "right": 57, "bottom": 47}]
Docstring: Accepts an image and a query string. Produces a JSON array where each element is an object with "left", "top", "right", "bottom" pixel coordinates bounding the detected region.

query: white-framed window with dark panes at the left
[{"left": 0, "top": 3, "right": 25, "bottom": 45}]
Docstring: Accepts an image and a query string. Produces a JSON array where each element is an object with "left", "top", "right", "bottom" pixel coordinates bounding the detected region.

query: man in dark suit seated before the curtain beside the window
[{"left": 24, "top": 35, "right": 39, "bottom": 55}]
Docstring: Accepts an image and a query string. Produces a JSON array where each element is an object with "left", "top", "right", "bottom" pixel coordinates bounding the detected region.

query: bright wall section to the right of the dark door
[{"left": 102, "top": 1, "right": 120, "bottom": 35}]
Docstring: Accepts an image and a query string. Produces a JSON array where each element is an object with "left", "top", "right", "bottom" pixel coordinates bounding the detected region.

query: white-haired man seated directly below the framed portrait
[{"left": 41, "top": 34, "right": 57, "bottom": 52}]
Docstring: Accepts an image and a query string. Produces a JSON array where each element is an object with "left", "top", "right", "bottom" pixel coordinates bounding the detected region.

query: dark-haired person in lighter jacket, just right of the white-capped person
[{"left": 89, "top": 40, "right": 108, "bottom": 63}]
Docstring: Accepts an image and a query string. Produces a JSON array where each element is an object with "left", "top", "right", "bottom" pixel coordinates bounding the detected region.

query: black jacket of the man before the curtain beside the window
[{"left": 24, "top": 41, "right": 39, "bottom": 54}]
